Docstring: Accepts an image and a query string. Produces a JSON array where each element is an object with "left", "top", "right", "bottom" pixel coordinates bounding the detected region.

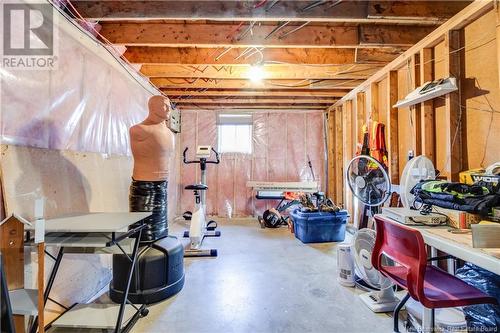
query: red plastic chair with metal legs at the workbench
[{"left": 372, "top": 215, "right": 498, "bottom": 332}]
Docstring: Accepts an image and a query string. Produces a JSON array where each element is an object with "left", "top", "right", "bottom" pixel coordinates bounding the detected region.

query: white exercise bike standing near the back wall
[{"left": 182, "top": 146, "right": 221, "bottom": 257}]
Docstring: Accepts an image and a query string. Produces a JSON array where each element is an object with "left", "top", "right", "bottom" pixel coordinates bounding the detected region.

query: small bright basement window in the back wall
[{"left": 217, "top": 113, "right": 253, "bottom": 154}]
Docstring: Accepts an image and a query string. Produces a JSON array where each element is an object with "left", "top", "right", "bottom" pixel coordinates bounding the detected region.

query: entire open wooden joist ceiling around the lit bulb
[{"left": 80, "top": 0, "right": 470, "bottom": 111}]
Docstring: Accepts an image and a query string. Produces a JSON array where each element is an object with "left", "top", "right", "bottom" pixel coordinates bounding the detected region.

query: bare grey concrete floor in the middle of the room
[{"left": 132, "top": 219, "right": 392, "bottom": 333}]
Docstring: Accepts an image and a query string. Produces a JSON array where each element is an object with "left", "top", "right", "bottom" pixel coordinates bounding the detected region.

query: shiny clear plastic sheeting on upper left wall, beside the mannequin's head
[{"left": 0, "top": 5, "right": 152, "bottom": 155}]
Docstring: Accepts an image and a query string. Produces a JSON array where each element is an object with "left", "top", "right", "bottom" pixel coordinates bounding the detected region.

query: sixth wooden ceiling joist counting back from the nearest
[{"left": 161, "top": 89, "right": 350, "bottom": 98}]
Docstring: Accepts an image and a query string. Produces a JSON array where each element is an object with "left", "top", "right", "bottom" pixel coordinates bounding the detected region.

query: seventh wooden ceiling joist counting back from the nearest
[{"left": 170, "top": 97, "right": 339, "bottom": 106}]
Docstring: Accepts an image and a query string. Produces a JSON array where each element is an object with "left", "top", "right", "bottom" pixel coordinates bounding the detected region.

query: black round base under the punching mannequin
[{"left": 109, "top": 237, "right": 184, "bottom": 304}]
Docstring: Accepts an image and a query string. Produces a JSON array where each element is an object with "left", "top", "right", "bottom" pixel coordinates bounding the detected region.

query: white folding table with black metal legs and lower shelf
[{"left": 28, "top": 212, "right": 151, "bottom": 333}]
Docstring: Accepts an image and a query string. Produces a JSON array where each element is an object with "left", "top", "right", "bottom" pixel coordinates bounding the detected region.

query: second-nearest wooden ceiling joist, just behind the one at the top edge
[{"left": 100, "top": 22, "right": 434, "bottom": 48}]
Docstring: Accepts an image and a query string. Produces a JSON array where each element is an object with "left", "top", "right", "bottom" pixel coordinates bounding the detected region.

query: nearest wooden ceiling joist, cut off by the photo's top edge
[{"left": 72, "top": 0, "right": 470, "bottom": 25}]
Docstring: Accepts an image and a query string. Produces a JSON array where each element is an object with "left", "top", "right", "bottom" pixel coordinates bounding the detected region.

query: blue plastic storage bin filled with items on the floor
[{"left": 290, "top": 208, "right": 349, "bottom": 243}]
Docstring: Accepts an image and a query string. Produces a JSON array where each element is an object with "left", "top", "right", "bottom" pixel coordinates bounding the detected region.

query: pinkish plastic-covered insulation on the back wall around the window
[{"left": 179, "top": 110, "right": 325, "bottom": 217}]
